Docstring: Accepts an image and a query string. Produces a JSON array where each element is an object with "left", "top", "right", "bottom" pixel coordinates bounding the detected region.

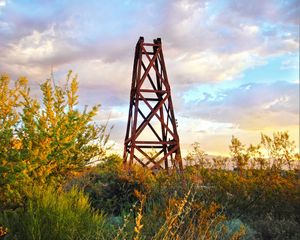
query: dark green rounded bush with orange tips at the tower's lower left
[{"left": 66, "top": 154, "right": 154, "bottom": 216}]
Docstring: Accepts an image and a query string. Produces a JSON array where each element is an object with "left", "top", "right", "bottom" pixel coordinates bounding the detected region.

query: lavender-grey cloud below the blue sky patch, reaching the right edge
[{"left": 182, "top": 82, "right": 299, "bottom": 130}]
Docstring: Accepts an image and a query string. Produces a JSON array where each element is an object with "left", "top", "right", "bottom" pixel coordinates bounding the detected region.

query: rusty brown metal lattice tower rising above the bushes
[{"left": 123, "top": 37, "right": 182, "bottom": 171}]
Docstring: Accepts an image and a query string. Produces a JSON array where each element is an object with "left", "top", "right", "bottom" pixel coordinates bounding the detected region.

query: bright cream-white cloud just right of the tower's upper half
[{"left": 169, "top": 51, "right": 265, "bottom": 85}]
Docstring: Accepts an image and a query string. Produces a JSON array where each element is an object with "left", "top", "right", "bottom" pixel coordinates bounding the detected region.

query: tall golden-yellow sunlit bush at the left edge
[{"left": 0, "top": 71, "right": 108, "bottom": 209}]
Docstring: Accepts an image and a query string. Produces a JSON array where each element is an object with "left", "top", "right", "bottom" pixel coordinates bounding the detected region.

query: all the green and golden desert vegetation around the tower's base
[{"left": 0, "top": 72, "right": 300, "bottom": 240}]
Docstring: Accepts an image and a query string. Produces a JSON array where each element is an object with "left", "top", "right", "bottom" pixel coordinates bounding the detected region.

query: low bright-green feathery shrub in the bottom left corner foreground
[{"left": 0, "top": 187, "right": 111, "bottom": 240}]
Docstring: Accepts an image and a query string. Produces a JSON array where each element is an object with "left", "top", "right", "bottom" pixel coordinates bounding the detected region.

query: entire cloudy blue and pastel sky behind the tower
[{"left": 0, "top": 0, "right": 300, "bottom": 155}]
